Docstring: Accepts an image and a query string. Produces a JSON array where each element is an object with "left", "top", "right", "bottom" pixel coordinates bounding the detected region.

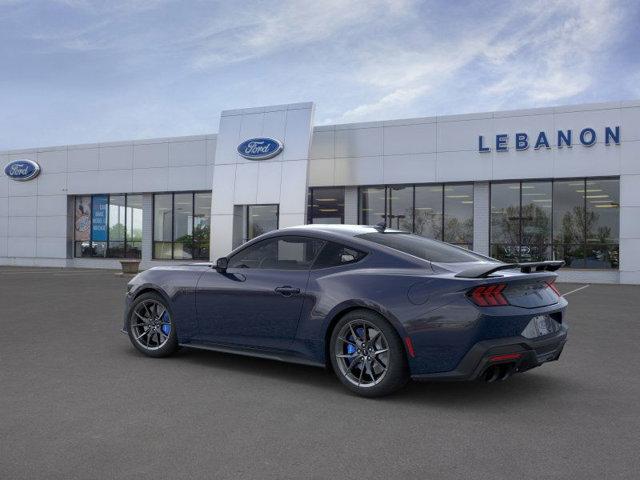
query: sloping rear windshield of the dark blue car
[{"left": 356, "top": 232, "right": 487, "bottom": 263}]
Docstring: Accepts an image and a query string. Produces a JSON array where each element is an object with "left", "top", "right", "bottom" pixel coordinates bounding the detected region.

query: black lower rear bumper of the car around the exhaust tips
[{"left": 411, "top": 325, "right": 567, "bottom": 381}]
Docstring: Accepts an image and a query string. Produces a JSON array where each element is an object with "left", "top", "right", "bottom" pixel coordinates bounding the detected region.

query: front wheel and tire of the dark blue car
[{"left": 127, "top": 292, "right": 178, "bottom": 358}]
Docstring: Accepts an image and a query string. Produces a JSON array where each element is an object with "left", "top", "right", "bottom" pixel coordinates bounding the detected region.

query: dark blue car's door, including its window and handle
[{"left": 196, "top": 236, "right": 323, "bottom": 349}]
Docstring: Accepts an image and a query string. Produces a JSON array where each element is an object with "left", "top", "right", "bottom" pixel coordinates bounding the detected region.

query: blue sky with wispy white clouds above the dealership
[{"left": 0, "top": 0, "right": 640, "bottom": 150}]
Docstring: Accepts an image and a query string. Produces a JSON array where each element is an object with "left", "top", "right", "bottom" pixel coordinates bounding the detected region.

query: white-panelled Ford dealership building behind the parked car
[{"left": 0, "top": 101, "right": 640, "bottom": 283}]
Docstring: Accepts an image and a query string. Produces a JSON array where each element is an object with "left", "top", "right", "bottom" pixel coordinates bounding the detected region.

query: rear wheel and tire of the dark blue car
[{"left": 329, "top": 310, "right": 409, "bottom": 397}]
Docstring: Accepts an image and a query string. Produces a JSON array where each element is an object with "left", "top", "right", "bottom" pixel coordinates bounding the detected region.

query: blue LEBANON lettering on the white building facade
[{"left": 478, "top": 126, "right": 620, "bottom": 153}]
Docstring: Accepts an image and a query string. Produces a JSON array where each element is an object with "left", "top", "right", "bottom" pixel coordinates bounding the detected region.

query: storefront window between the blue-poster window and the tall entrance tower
[{"left": 153, "top": 192, "right": 211, "bottom": 260}]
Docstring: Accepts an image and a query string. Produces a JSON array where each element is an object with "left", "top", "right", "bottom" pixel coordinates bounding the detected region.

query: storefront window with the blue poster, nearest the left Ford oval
[{"left": 74, "top": 194, "right": 142, "bottom": 258}]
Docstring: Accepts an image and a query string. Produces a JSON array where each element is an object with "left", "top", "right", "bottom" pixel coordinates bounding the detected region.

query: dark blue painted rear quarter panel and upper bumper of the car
[{"left": 298, "top": 267, "right": 566, "bottom": 374}]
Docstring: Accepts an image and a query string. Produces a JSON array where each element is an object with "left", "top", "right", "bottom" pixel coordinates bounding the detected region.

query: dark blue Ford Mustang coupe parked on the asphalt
[{"left": 124, "top": 225, "right": 567, "bottom": 396}]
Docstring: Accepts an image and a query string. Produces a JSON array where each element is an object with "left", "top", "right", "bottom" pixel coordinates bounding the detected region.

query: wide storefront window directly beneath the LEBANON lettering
[{"left": 491, "top": 178, "right": 620, "bottom": 269}]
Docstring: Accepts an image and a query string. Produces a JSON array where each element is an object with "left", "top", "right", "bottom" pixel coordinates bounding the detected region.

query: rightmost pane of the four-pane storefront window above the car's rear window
[{"left": 443, "top": 184, "right": 473, "bottom": 249}]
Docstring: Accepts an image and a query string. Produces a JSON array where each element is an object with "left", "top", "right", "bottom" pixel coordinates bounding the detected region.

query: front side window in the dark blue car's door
[{"left": 228, "top": 237, "right": 324, "bottom": 270}]
